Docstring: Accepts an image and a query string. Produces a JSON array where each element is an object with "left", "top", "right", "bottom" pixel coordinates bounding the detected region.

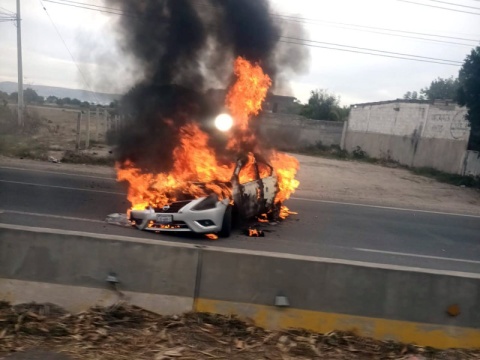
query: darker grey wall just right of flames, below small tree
[{"left": 259, "top": 113, "right": 345, "bottom": 150}]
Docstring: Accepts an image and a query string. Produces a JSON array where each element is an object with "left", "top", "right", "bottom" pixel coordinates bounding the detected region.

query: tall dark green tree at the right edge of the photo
[{"left": 456, "top": 46, "right": 480, "bottom": 151}]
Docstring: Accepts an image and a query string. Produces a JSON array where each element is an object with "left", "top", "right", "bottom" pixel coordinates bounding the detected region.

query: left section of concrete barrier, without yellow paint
[{"left": 0, "top": 225, "right": 198, "bottom": 314}]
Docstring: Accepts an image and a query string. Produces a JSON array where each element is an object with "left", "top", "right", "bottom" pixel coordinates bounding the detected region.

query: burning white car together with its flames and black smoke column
[{"left": 106, "top": 0, "right": 308, "bottom": 236}]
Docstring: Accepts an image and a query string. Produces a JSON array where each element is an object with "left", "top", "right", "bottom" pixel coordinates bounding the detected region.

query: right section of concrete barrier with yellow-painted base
[{"left": 196, "top": 250, "right": 480, "bottom": 348}]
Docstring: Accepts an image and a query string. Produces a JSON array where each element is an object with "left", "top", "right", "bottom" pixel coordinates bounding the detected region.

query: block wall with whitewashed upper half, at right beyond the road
[{"left": 344, "top": 101, "right": 470, "bottom": 173}]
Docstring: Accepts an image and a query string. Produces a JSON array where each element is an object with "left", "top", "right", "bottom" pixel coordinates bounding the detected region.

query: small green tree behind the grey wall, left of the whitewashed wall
[{"left": 300, "top": 89, "right": 348, "bottom": 120}]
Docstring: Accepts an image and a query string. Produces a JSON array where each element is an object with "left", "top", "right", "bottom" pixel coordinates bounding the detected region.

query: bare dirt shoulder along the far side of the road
[{"left": 0, "top": 154, "right": 480, "bottom": 215}]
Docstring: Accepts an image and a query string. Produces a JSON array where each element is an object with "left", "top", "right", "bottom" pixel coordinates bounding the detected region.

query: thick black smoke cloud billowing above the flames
[{"left": 109, "top": 0, "right": 310, "bottom": 172}]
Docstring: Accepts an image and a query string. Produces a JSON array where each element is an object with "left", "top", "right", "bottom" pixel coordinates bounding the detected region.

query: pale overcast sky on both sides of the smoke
[{"left": 0, "top": 0, "right": 480, "bottom": 105}]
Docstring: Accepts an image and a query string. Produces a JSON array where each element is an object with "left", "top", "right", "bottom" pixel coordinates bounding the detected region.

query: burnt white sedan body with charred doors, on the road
[{"left": 127, "top": 155, "right": 280, "bottom": 237}]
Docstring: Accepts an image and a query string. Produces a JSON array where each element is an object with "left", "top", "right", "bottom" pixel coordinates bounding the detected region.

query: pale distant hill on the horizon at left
[{"left": 0, "top": 81, "right": 121, "bottom": 104}]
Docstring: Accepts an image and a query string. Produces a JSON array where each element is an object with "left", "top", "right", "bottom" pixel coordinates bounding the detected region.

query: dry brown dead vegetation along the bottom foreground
[{"left": 0, "top": 302, "right": 480, "bottom": 360}]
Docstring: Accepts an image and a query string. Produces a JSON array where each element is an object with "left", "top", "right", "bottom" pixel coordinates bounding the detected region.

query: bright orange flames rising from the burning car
[{"left": 116, "top": 57, "right": 299, "bottom": 217}]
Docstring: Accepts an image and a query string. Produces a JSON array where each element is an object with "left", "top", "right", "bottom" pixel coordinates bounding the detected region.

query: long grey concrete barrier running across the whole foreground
[{"left": 0, "top": 224, "right": 480, "bottom": 348}]
